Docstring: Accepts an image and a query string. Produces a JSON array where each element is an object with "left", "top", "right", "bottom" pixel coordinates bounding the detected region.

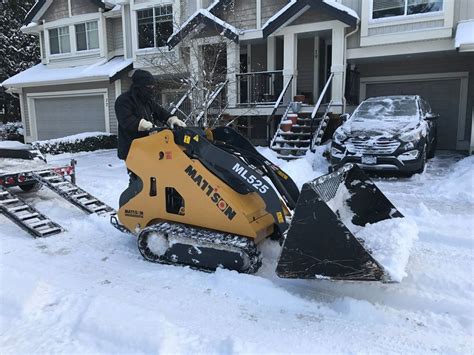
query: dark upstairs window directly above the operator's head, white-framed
[{"left": 137, "top": 5, "right": 173, "bottom": 48}]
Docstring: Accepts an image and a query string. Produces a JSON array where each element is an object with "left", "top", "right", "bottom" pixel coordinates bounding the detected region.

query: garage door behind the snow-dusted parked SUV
[{"left": 366, "top": 79, "right": 461, "bottom": 150}]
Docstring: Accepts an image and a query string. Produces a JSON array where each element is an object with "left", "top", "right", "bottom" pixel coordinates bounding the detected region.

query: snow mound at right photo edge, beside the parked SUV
[{"left": 430, "top": 156, "right": 474, "bottom": 203}]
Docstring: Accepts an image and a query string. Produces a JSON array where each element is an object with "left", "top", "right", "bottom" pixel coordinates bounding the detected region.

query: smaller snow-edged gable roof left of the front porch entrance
[{"left": 168, "top": 9, "right": 240, "bottom": 49}]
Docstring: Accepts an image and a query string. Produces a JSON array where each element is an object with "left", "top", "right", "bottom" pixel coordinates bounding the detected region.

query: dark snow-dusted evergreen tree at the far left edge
[{"left": 0, "top": 0, "right": 40, "bottom": 121}]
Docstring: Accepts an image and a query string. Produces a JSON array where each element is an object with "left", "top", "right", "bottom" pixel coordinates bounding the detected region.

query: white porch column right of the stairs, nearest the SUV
[{"left": 331, "top": 24, "right": 346, "bottom": 105}]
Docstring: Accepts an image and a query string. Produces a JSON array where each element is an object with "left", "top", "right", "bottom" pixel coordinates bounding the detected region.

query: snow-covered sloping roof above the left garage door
[{"left": 1, "top": 57, "right": 132, "bottom": 88}]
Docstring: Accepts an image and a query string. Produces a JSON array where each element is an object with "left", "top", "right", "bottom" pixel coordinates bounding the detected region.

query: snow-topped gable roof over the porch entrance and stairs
[{"left": 262, "top": 0, "right": 359, "bottom": 38}]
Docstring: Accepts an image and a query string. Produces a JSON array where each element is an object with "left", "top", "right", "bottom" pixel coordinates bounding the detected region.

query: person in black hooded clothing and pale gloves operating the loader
[{"left": 115, "top": 69, "right": 186, "bottom": 160}]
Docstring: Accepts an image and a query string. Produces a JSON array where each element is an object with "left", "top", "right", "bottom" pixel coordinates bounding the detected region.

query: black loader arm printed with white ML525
[{"left": 173, "top": 127, "right": 288, "bottom": 234}]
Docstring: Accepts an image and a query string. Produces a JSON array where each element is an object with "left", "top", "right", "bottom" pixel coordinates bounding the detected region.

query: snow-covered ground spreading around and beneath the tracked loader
[{"left": 0, "top": 150, "right": 474, "bottom": 354}]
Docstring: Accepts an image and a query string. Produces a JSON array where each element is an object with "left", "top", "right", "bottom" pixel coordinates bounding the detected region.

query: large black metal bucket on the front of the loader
[{"left": 276, "top": 164, "right": 403, "bottom": 281}]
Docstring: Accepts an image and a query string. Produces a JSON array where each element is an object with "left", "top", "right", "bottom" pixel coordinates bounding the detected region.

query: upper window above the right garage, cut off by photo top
[{"left": 372, "top": 0, "right": 443, "bottom": 19}]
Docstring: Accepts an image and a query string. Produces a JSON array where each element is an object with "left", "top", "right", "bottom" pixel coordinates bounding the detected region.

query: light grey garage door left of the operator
[{"left": 34, "top": 95, "right": 105, "bottom": 140}]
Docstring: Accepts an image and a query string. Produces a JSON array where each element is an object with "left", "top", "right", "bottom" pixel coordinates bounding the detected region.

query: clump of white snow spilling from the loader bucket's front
[{"left": 355, "top": 217, "right": 418, "bottom": 282}]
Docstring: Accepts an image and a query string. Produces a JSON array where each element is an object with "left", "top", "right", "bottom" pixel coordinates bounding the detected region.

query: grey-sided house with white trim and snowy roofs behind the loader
[{"left": 2, "top": 0, "right": 474, "bottom": 150}]
